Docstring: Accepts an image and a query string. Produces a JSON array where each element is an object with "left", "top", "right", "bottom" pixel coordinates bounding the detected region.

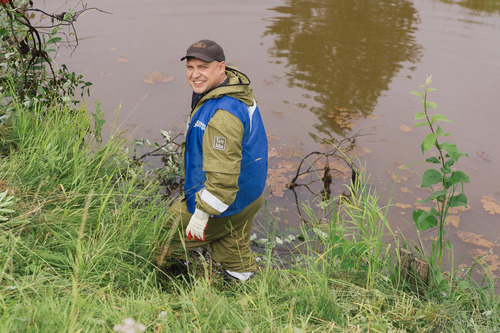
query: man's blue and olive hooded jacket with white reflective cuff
[{"left": 184, "top": 67, "right": 268, "bottom": 216}]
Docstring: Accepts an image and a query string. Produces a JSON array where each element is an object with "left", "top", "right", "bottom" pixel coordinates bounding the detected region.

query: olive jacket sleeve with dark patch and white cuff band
[{"left": 196, "top": 110, "right": 244, "bottom": 215}]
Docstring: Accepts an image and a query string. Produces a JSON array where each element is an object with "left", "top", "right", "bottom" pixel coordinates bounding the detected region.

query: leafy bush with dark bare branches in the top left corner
[{"left": 0, "top": 0, "right": 91, "bottom": 121}]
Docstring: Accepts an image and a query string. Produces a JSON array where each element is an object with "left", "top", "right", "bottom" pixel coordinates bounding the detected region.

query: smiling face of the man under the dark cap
[{"left": 186, "top": 58, "right": 226, "bottom": 94}]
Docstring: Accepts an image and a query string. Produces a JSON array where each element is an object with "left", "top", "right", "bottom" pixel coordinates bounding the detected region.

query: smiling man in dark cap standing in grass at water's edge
[{"left": 159, "top": 39, "right": 267, "bottom": 281}]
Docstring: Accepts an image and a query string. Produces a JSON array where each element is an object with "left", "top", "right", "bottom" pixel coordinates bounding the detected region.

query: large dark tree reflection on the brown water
[{"left": 265, "top": 0, "right": 421, "bottom": 137}]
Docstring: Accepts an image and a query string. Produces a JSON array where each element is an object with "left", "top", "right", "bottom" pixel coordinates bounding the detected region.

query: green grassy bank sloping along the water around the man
[{"left": 0, "top": 102, "right": 500, "bottom": 332}]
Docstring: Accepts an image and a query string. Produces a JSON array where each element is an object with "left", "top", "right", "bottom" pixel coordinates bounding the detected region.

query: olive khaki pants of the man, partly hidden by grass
[{"left": 157, "top": 195, "right": 263, "bottom": 272}]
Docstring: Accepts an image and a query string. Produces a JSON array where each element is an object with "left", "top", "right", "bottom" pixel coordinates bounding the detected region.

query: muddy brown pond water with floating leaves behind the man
[{"left": 44, "top": 0, "right": 500, "bottom": 286}]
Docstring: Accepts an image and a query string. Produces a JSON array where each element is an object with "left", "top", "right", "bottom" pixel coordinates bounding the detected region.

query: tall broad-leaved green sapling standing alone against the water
[{"left": 411, "top": 76, "right": 470, "bottom": 268}]
